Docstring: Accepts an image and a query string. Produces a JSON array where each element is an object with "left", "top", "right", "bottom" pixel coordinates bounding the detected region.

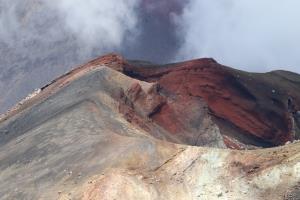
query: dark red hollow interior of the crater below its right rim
[{"left": 95, "top": 54, "right": 300, "bottom": 148}]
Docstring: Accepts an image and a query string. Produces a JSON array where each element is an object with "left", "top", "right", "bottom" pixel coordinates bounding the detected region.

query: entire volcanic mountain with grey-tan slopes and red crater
[{"left": 0, "top": 54, "right": 300, "bottom": 199}]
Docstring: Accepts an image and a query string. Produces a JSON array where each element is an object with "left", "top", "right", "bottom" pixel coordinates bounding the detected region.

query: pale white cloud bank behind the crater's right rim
[{"left": 177, "top": 0, "right": 300, "bottom": 72}]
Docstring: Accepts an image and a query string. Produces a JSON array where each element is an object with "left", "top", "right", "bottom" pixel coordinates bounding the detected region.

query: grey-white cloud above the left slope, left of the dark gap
[{"left": 0, "top": 0, "right": 139, "bottom": 113}]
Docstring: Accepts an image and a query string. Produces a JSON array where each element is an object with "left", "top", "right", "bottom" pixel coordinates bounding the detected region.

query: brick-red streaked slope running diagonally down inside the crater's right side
[{"left": 155, "top": 62, "right": 291, "bottom": 145}]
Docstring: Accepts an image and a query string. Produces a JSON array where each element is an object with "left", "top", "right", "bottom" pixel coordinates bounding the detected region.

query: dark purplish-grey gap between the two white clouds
[{"left": 121, "top": 0, "right": 187, "bottom": 63}]
